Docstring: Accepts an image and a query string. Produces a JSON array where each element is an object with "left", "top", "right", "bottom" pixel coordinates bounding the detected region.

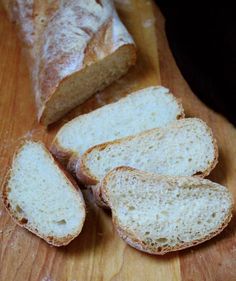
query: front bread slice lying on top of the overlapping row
[{"left": 101, "top": 167, "right": 233, "bottom": 255}]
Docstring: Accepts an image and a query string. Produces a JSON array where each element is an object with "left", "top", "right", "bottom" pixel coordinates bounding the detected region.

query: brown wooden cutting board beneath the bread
[{"left": 0, "top": 0, "right": 236, "bottom": 281}]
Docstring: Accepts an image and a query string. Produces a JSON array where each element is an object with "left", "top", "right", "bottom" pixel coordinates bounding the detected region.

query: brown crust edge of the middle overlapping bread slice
[{"left": 76, "top": 118, "right": 219, "bottom": 185}]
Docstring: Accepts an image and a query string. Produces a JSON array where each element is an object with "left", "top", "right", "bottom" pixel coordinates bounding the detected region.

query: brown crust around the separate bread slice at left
[{"left": 2, "top": 141, "right": 86, "bottom": 247}]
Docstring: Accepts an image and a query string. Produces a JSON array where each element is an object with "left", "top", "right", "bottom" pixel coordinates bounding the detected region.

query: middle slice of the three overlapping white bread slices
[{"left": 76, "top": 118, "right": 218, "bottom": 185}]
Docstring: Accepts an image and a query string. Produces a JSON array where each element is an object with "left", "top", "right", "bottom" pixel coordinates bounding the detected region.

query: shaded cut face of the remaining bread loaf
[{"left": 39, "top": 44, "right": 136, "bottom": 126}]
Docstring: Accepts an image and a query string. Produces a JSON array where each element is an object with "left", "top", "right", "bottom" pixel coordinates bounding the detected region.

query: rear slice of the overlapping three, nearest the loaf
[{"left": 51, "top": 87, "right": 184, "bottom": 166}]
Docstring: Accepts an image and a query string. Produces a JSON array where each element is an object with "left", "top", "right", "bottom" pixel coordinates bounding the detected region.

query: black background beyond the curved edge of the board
[{"left": 156, "top": 0, "right": 236, "bottom": 125}]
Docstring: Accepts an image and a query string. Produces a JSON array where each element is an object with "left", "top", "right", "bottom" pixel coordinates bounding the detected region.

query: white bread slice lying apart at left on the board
[{"left": 3, "top": 141, "right": 85, "bottom": 246}]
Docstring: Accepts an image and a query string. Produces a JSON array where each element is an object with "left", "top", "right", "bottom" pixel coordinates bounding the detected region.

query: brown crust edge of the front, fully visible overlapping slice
[{"left": 100, "top": 166, "right": 233, "bottom": 255}]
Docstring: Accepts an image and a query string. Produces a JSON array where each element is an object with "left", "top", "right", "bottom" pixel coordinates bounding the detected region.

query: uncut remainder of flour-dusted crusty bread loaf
[{"left": 3, "top": 0, "right": 136, "bottom": 125}]
